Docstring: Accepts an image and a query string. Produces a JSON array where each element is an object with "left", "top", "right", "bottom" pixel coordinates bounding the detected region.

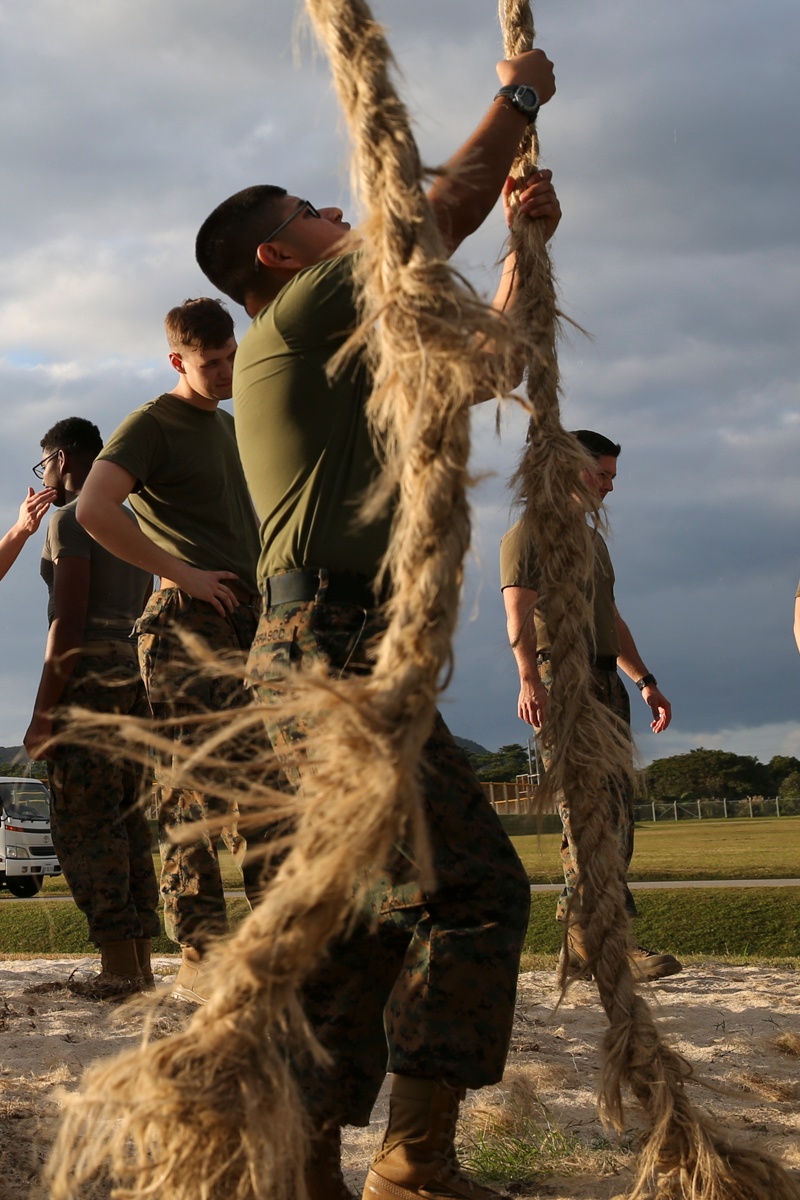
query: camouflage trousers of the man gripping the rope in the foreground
[{"left": 248, "top": 601, "right": 530, "bottom": 1124}]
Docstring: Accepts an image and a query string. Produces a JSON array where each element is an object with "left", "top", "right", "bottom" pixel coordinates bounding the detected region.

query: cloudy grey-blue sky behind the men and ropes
[{"left": 0, "top": 0, "right": 800, "bottom": 760}]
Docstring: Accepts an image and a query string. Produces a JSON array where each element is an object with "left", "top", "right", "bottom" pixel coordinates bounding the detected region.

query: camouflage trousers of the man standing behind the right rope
[{"left": 539, "top": 659, "right": 637, "bottom": 920}]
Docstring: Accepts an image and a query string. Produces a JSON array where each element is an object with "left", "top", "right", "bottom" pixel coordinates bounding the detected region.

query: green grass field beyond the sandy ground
[{"left": 0, "top": 817, "right": 800, "bottom": 970}]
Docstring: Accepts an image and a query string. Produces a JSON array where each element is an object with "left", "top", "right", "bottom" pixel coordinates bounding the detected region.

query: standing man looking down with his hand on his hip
[{"left": 78, "top": 298, "right": 260, "bottom": 1003}]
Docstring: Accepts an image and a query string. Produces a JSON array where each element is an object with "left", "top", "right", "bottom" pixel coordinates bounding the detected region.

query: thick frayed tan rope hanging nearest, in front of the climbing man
[{"left": 53, "top": 0, "right": 525, "bottom": 1200}]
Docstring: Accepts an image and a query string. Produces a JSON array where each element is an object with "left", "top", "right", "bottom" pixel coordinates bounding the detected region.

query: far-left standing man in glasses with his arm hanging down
[{"left": 24, "top": 416, "right": 161, "bottom": 1000}]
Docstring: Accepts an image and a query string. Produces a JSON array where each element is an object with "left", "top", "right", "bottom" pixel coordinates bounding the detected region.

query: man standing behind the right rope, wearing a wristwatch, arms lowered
[{"left": 500, "top": 430, "right": 681, "bottom": 979}]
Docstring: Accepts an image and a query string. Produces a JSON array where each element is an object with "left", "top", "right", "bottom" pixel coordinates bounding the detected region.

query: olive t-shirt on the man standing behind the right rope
[{"left": 500, "top": 522, "right": 620, "bottom": 658}]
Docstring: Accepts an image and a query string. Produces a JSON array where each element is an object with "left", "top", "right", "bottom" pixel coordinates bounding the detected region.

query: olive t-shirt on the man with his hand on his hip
[{"left": 97, "top": 392, "right": 258, "bottom": 593}]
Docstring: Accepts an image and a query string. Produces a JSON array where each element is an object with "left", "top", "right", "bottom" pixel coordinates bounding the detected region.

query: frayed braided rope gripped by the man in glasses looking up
[{"left": 499, "top": 0, "right": 800, "bottom": 1200}]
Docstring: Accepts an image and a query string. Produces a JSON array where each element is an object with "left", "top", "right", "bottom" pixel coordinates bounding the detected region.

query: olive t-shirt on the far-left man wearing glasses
[{"left": 40, "top": 499, "right": 152, "bottom": 642}]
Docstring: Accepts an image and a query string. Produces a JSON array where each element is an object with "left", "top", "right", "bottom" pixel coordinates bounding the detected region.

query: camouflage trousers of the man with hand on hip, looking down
[{"left": 136, "top": 588, "right": 267, "bottom": 949}]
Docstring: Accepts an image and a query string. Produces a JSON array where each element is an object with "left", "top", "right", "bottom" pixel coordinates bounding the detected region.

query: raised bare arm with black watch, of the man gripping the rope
[{"left": 428, "top": 50, "right": 555, "bottom": 254}]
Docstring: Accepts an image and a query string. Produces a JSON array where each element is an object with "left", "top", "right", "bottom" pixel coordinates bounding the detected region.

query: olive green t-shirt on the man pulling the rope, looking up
[{"left": 234, "top": 254, "right": 389, "bottom": 588}]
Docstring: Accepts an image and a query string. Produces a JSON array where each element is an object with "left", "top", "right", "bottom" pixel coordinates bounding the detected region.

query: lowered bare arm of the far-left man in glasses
[{"left": 23, "top": 557, "right": 91, "bottom": 758}]
